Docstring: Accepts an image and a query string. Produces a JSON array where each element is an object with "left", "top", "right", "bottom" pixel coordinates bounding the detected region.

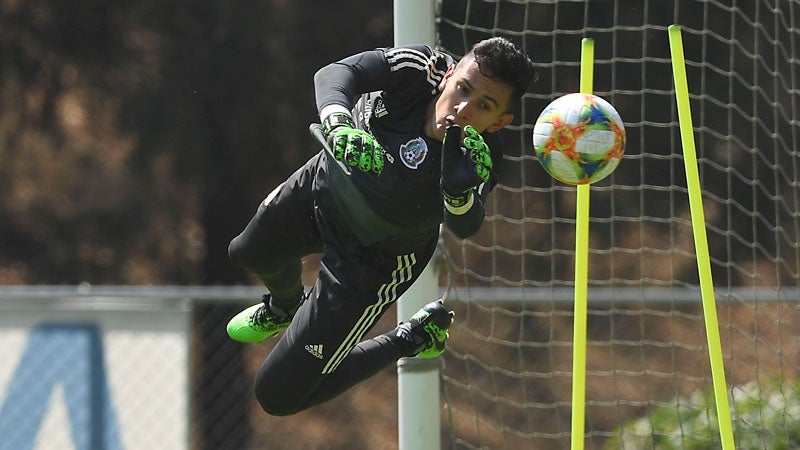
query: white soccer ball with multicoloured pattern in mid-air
[{"left": 533, "top": 93, "right": 625, "bottom": 185}]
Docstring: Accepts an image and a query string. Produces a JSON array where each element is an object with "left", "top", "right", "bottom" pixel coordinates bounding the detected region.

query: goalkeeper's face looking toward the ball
[{"left": 426, "top": 60, "right": 514, "bottom": 141}]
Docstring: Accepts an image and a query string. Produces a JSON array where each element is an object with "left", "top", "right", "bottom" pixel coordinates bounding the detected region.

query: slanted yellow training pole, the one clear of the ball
[{"left": 668, "top": 25, "right": 734, "bottom": 450}]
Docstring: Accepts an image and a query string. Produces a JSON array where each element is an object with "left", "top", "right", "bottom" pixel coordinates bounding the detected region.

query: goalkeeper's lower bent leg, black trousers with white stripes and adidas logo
[{"left": 255, "top": 242, "right": 450, "bottom": 415}]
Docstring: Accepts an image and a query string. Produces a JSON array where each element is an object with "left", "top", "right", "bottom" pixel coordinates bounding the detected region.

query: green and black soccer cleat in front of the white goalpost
[{"left": 397, "top": 300, "right": 455, "bottom": 358}]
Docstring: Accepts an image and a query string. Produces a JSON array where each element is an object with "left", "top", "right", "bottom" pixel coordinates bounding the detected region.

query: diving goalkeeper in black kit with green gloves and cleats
[{"left": 227, "top": 38, "right": 534, "bottom": 415}]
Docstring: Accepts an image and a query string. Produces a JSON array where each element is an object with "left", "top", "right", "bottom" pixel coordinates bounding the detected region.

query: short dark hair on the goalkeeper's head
[{"left": 462, "top": 37, "right": 536, "bottom": 111}]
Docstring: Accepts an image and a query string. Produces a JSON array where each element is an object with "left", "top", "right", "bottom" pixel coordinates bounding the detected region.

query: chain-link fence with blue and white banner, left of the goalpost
[{"left": 0, "top": 286, "right": 397, "bottom": 450}]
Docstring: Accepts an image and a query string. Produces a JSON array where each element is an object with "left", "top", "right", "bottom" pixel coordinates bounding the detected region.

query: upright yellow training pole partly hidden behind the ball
[{"left": 571, "top": 38, "right": 594, "bottom": 450}]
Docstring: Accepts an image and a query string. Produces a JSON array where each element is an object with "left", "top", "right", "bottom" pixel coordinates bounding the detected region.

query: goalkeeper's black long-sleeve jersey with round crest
[{"left": 314, "top": 46, "right": 502, "bottom": 248}]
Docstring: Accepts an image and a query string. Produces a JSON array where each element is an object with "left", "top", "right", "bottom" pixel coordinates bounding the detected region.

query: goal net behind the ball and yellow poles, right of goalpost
[{"left": 437, "top": 0, "right": 800, "bottom": 449}]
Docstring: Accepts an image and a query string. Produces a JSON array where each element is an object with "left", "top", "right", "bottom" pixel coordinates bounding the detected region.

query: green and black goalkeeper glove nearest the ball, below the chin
[{"left": 442, "top": 125, "right": 493, "bottom": 214}]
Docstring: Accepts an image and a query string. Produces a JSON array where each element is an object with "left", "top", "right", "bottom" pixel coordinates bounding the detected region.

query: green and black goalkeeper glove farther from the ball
[{"left": 322, "top": 112, "right": 383, "bottom": 175}]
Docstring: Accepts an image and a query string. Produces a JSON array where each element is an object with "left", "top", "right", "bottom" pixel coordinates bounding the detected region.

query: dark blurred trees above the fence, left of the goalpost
[{"left": 0, "top": 0, "right": 392, "bottom": 284}]
